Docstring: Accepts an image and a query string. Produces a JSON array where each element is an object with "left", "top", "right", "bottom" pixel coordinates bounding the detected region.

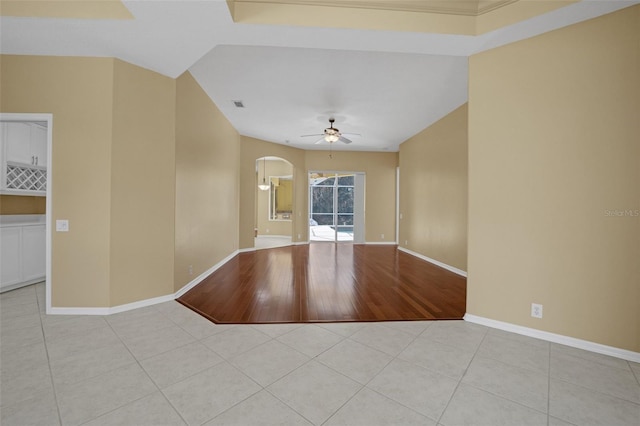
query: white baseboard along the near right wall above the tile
[{"left": 464, "top": 313, "right": 640, "bottom": 363}]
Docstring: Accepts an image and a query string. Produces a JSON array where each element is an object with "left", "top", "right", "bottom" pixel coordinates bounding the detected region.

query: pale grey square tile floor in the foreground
[{"left": 0, "top": 284, "right": 640, "bottom": 426}]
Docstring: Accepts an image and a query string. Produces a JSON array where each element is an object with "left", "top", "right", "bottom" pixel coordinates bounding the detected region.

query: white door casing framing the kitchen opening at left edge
[{"left": 0, "top": 113, "right": 53, "bottom": 314}]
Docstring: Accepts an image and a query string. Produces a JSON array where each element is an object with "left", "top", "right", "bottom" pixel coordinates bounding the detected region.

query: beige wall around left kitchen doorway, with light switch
[{"left": 0, "top": 55, "right": 114, "bottom": 307}]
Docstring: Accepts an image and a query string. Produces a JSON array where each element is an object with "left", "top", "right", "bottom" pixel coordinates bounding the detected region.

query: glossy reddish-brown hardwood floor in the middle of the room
[{"left": 178, "top": 243, "right": 467, "bottom": 324}]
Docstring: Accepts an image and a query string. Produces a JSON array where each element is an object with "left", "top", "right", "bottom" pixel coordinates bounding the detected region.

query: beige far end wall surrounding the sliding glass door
[{"left": 304, "top": 151, "right": 398, "bottom": 242}]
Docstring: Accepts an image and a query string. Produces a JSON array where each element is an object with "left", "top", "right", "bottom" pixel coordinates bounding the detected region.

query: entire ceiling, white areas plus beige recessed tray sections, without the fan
[{"left": 0, "top": 0, "right": 640, "bottom": 151}]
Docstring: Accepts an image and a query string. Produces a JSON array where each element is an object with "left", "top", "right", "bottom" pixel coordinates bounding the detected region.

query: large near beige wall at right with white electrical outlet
[{"left": 467, "top": 6, "right": 640, "bottom": 352}]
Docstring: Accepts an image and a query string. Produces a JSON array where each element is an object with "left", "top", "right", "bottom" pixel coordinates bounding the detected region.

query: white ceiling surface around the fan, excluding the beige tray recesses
[{"left": 0, "top": 0, "right": 640, "bottom": 151}]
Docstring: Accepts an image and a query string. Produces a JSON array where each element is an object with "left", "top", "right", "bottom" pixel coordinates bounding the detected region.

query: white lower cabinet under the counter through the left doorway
[{"left": 0, "top": 224, "right": 47, "bottom": 292}]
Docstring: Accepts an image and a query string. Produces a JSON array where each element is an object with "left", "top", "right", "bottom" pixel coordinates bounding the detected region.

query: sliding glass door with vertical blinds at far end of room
[{"left": 309, "top": 172, "right": 364, "bottom": 243}]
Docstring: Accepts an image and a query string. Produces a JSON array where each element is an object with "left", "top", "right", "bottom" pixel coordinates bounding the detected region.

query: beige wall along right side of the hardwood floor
[{"left": 399, "top": 104, "right": 468, "bottom": 271}]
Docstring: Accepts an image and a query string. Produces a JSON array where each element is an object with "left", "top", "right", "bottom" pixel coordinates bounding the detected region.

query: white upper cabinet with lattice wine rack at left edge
[{"left": 0, "top": 122, "right": 47, "bottom": 195}]
